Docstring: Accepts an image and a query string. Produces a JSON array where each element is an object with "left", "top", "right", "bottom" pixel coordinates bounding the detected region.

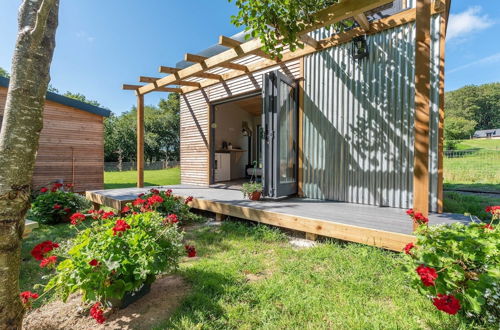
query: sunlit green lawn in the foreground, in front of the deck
[{"left": 21, "top": 221, "right": 467, "bottom": 329}]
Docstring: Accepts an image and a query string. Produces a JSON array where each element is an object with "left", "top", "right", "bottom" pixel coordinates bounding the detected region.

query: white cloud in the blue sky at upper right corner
[{"left": 446, "top": 6, "right": 494, "bottom": 40}]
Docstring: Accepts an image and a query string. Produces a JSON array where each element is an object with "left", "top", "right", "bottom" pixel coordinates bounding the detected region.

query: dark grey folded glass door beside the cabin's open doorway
[{"left": 262, "top": 71, "right": 298, "bottom": 197}]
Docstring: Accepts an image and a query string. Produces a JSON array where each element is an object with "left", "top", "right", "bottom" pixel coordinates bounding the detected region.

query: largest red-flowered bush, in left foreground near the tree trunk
[{"left": 42, "top": 212, "right": 183, "bottom": 305}]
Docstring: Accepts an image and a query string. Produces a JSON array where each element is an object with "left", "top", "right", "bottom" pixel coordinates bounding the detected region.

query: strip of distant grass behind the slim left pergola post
[{"left": 104, "top": 167, "right": 181, "bottom": 189}]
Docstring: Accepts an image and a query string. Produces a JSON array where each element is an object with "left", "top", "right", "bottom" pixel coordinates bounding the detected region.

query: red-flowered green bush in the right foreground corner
[{"left": 405, "top": 206, "right": 500, "bottom": 324}]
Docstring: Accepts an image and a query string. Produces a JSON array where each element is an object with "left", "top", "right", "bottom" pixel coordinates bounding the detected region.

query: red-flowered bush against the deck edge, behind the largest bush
[{"left": 126, "top": 189, "right": 203, "bottom": 224}]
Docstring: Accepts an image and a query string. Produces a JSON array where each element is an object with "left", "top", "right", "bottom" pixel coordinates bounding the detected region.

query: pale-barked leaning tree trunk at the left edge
[{"left": 0, "top": 0, "right": 59, "bottom": 329}]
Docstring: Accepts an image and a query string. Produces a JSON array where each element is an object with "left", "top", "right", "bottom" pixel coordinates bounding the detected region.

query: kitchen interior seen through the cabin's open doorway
[{"left": 212, "top": 95, "right": 262, "bottom": 188}]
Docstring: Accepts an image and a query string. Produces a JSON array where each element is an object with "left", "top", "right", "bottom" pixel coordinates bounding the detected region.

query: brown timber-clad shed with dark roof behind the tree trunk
[{"left": 0, "top": 77, "right": 111, "bottom": 192}]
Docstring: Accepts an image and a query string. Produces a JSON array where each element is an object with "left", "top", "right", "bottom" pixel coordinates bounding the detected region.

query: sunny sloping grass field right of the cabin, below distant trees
[{"left": 443, "top": 139, "right": 500, "bottom": 192}]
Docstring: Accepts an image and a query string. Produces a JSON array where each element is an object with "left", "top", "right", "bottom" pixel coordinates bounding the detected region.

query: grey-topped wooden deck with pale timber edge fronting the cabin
[{"left": 86, "top": 185, "right": 469, "bottom": 251}]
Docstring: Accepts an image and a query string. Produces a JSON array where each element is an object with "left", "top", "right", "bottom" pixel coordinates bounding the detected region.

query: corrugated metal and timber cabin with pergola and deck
[{"left": 87, "top": 0, "right": 460, "bottom": 251}]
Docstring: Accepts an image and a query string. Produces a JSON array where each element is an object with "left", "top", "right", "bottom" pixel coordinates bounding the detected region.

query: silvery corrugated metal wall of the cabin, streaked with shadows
[{"left": 303, "top": 17, "right": 439, "bottom": 211}]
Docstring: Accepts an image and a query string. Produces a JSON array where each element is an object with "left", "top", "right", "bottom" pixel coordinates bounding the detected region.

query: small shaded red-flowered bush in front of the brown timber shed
[{"left": 31, "top": 183, "right": 90, "bottom": 224}]
